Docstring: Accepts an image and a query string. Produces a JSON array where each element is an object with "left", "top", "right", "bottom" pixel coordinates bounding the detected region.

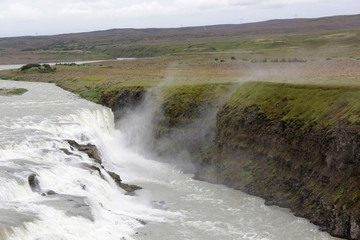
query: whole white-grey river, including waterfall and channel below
[{"left": 0, "top": 80, "right": 342, "bottom": 240}]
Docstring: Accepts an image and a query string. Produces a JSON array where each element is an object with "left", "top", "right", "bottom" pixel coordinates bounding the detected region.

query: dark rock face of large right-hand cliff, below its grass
[{"left": 196, "top": 102, "right": 360, "bottom": 239}]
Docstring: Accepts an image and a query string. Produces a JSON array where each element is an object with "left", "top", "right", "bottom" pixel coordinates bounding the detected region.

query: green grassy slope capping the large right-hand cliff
[{"left": 222, "top": 82, "right": 360, "bottom": 127}]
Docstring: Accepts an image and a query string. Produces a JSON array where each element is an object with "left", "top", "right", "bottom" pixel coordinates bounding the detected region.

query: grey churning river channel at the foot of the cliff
[{"left": 102, "top": 132, "right": 338, "bottom": 240}]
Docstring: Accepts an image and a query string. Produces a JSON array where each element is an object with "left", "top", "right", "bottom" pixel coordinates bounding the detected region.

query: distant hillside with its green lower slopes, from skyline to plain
[{"left": 0, "top": 15, "right": 360, "bottom": 64}]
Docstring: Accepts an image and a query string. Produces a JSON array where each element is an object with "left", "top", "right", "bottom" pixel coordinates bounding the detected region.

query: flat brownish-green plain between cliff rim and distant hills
[{"left": 0, "top": 54, "right": 360, "bottom": 102}]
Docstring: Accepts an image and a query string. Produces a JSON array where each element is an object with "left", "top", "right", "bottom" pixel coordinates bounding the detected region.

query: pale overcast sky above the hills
[{"left": 0, "top": 0, "right": 360, "bottom": 37}]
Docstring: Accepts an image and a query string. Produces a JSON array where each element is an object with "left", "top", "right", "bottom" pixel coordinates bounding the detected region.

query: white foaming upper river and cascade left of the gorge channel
[{"left": 0, "top": 81, "right": 167, "bottom": 239}]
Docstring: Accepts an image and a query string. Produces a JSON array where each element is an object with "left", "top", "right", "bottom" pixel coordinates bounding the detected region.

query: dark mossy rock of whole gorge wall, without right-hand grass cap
[{"left": 97, "top": 86, "right": 360, "bottom": 239}]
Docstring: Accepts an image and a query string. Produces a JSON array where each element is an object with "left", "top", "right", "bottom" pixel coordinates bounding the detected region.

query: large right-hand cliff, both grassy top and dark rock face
[{"left": 197, "top": 82, "right": 360, "bottom": 239}]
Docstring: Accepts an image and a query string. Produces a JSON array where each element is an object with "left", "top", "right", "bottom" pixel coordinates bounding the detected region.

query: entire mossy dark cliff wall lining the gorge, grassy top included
[{"left": 98, "top": 82, "right": 360, "bottom": 239}]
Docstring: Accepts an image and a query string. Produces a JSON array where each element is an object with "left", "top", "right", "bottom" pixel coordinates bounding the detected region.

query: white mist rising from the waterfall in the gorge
[{"left": 116, "top": 72, "right": 235, "bottom": 173}]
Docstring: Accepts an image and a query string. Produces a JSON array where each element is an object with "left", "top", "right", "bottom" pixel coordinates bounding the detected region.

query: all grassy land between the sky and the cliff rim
[{"left": 0, "top": 15, "right": 360, "bottom": 102}]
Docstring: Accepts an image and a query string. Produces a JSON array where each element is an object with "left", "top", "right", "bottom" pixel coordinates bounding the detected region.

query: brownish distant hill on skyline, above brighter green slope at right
[{"left": 0, "top": 15, "right": 360, "bottom": 63}]
